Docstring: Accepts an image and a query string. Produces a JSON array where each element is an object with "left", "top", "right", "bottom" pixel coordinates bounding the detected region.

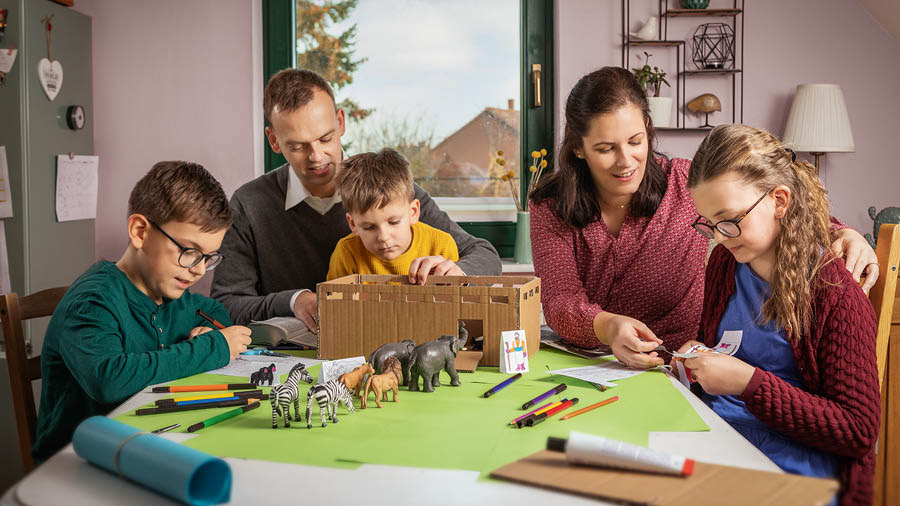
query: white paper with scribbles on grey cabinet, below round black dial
[{"left": 56, "top": 155, "right": 100, "bottom": 221}]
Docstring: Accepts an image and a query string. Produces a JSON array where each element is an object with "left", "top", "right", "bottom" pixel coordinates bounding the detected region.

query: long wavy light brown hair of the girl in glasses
[{"left": 688, "top": 125, "right": 834, "bottom": 338}]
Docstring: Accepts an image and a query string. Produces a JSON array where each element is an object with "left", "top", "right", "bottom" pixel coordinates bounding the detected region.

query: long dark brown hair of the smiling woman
[{"left": 531, "top": 67, "right": 667, "bottom": 228}]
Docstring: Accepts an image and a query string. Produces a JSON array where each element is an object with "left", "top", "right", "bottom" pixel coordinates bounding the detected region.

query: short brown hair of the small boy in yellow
[{"left": 338, "top": 148, "right": 413, "bottom": 213}]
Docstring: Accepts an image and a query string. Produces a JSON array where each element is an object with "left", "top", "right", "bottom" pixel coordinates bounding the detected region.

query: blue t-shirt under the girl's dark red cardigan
[{"left": 703, "top": 263, "right": 838, "bottom": 478}]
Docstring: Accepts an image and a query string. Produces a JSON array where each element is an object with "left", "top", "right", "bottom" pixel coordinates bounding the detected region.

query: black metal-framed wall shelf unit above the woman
[{"left": 622, "top": 0, "right": 745, "bottom": 132}]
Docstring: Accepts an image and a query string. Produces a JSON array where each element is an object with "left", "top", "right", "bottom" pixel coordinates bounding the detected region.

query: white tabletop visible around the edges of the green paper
[{"left": 0, "top": 359, "right": 781, "bottom": 506}]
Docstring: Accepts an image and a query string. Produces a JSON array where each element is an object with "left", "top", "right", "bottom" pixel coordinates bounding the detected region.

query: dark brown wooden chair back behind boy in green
[{"left": 0, "top": 286, "right": 68, "bottom": 474}]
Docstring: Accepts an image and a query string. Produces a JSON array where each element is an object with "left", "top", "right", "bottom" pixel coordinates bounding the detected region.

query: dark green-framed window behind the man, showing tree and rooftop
[{"left": 263, "top": 0, "right": 553, "bottom": 255}]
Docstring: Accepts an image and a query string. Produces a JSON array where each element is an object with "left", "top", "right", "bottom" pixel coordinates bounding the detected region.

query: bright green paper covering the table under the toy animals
[{"left": 117, "top": 348, "right": 709, "bottom": 477}]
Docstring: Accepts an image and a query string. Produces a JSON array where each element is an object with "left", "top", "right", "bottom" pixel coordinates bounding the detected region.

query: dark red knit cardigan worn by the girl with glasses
[{"left": 700, "top": 245, "right": 881, "bottom": 505}]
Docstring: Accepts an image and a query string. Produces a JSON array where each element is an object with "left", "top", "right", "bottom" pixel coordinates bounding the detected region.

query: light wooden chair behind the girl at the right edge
[{"left": 869, "top": 224, "right": 900, "bottom": 505}]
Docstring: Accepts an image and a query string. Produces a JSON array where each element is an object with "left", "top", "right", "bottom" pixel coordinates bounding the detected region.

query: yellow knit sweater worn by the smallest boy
[{"left": 326, "top": 221, "right": 459, "bottom": 281}]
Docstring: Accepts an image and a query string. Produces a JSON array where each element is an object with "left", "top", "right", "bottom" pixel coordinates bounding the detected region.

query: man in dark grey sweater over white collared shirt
[{"left": 211, "top": 69, "right": 500, "bottom": 332}]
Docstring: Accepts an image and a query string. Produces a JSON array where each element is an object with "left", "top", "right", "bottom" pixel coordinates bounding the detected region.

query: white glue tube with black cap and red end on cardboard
[{"left": 547, "top": 431, "right": 694, "bottom": 476}]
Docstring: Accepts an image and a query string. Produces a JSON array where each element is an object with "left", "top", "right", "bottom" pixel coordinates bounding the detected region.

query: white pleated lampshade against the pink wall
[{"left": 784, "top": 84, "right": 856, "bottom": 153}]
